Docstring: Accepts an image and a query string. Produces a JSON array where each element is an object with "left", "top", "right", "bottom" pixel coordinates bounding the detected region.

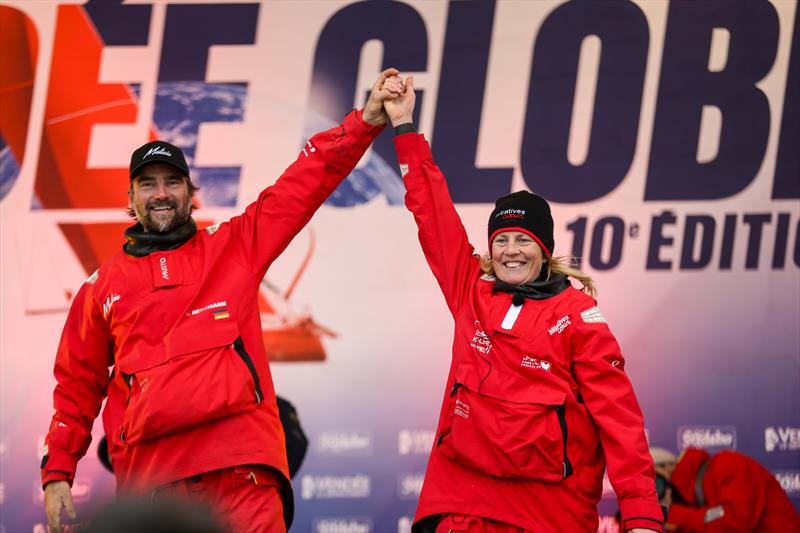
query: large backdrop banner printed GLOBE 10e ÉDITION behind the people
[{"left": 0, "top": 0, "right": 800, "bottom": 533}]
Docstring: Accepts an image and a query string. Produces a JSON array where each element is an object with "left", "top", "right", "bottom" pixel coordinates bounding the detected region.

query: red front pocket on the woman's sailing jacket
[{"left": 436, "top": 382, "right": 572, "bottom": 482}]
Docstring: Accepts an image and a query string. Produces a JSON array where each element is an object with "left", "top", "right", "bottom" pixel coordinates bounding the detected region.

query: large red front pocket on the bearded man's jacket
[{"left": 120, "top": 323, "right": 263, "bottom": 445}]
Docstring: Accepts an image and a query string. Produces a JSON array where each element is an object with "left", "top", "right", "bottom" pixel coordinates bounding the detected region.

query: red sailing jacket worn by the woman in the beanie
[{"left": 395, "top": 134, "right": 663, "bottom": 532}]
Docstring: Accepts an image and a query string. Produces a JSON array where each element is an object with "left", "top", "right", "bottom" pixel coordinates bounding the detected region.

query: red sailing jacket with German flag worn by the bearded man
[{"left": 42, "top": 111, "right": 382, "bottom": 512}]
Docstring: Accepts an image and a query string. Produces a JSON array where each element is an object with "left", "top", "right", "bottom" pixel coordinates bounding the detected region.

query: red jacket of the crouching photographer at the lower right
[{"left": 667, "top": 448, "right": 800, "bottom": 533}]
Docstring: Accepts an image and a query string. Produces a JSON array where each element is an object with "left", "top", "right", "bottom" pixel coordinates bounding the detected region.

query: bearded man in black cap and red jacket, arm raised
[{"left": 41, "top": 69, "right": 401, "bottom": 532}]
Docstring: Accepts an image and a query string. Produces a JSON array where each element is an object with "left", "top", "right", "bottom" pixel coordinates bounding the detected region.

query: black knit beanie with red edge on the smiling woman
[{"left": 489, "top": 191, "right": 555, "bottom": 257}]
